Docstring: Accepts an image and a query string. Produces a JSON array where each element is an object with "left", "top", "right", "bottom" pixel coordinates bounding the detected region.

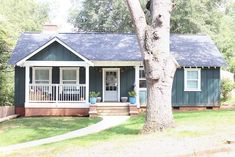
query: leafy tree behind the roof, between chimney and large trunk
[{"left": 69, "top": 0, "right": 146, "bottom": 33}]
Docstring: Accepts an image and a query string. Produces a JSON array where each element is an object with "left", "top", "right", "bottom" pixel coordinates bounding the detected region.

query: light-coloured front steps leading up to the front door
[{"left": 97, "top": 103, "right": 129, "bottom": 116}]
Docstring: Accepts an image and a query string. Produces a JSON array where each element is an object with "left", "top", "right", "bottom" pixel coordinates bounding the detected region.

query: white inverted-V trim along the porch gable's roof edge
[{"left": 16, "top": 37, "right": 93, "bottom": 66}]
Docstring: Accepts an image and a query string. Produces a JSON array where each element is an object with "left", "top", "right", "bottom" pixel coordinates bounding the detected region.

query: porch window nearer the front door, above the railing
[{"left": 60, "top": 68, "right": 79, "bottom": 84}]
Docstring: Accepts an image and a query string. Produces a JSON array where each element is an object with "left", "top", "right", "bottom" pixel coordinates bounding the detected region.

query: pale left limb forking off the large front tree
[{"left": 126, "top": 0, "right": 147, "bottom": 52}]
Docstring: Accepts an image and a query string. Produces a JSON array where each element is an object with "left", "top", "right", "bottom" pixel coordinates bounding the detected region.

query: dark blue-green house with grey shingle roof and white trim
[{"left": 9, "top": 33, "right": 225, "bottom": 116}]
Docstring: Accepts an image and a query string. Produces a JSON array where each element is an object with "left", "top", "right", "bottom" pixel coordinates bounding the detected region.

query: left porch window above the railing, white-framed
[{"left": 33, "top": 67, "right": 51, "bottom": 84}]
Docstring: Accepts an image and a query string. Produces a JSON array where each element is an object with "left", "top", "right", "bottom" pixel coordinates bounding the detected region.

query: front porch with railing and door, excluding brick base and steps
[{"left": 24, "top": 61, "right": 139, "bottom": 108}]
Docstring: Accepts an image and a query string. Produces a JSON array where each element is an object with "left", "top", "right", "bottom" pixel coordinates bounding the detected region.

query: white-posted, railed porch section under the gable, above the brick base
[{"left": 25, "top": 61, "right": 89, "bottom": 108}]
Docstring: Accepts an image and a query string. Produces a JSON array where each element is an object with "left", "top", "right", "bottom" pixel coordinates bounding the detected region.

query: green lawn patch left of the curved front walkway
[{"left": 0, "top": 117, "right": 101, "bottom": 147}]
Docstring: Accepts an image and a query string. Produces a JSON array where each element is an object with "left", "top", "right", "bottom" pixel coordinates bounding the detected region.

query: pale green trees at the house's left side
[{"left": 0, "top": 0, "right": 48, "bottom": 105}]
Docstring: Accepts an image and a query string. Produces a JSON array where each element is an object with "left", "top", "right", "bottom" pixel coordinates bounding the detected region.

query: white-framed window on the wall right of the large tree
[{"left": 184, "top": 68, "right": 201, "bottom": 91}]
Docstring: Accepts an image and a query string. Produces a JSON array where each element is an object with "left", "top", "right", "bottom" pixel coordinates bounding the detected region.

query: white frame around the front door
[{"left": 102, "top": 68, "right": 121, "bottom": 102}]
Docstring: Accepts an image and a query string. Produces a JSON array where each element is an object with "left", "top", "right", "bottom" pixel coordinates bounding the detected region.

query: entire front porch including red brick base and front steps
[{"left": 18, "top": 61, "right": 140, "bottom": 116}]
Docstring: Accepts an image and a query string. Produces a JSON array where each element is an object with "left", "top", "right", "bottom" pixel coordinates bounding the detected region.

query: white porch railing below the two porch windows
[{"left": 29, "top": 84, "right": 86, "bottom": 103}]
